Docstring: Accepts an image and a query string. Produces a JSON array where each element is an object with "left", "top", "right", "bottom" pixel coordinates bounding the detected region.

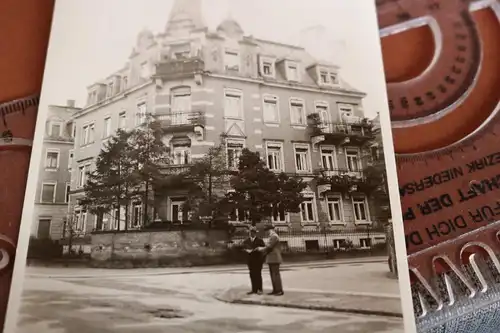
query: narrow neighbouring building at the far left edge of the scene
[{"left": 31, "top": 101, "right": 80, "bottom": 240}]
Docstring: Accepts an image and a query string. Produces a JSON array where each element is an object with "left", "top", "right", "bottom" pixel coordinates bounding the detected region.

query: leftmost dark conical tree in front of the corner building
[{"left": 80, "top": 130, "right": 137, "bottom": 229}]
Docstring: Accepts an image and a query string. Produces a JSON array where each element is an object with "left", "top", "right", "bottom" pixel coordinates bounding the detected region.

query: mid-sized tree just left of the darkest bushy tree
[{"left": 180, "top": 145, "right": 229, "bottom": 221}]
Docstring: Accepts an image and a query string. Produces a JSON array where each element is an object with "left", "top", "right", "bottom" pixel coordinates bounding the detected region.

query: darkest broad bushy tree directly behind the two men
[{"left": 222, "top": 149, "right": 307, "bottom": 225}]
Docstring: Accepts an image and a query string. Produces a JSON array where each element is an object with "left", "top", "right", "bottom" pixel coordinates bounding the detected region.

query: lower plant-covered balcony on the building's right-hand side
[{"left": 315, "top": 168, "right": 381, "bottom": 192}]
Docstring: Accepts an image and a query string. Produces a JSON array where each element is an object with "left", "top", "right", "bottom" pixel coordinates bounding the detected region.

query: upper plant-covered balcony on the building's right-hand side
[{"left": 307, "top": 113, "right": 374, "bottom": 144}]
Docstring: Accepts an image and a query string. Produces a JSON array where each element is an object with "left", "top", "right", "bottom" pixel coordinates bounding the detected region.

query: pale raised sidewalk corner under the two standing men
[{"left": 215, "top": 288, "right": 403, "bottom": 318}]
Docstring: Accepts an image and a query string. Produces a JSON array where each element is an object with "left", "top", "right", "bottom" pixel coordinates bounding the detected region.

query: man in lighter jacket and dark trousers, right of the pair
[{"left": 261, "top": 225, "right": 284, "bottom": 296}]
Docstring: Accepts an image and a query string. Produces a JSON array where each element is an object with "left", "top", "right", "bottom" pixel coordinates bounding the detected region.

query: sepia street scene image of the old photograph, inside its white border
[{"left": 7, "top": 0, "right": 403, "bottom": 333}]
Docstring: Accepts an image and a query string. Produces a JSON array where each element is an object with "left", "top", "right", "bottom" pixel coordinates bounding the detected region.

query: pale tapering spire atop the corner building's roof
[{"left": 165, "top": 0, "right": 206, "bottom": 35}]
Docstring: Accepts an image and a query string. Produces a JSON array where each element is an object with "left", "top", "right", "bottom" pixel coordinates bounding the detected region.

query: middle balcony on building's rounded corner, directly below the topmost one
[{"left": 155, "top": 111, "right": 205, "bottom": 133}]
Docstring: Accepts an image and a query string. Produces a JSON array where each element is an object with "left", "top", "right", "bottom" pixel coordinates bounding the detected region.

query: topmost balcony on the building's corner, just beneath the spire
[{"left": 154, "top": 57, "right": 205, "bottom": 80}]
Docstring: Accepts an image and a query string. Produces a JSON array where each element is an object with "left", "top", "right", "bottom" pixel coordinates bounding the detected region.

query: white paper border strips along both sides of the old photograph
[{"left": 4, "top": 1, "right": 416, "bottom": 333}]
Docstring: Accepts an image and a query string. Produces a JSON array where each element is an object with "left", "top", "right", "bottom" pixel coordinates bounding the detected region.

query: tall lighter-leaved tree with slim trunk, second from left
[{"left": 128, "top": 121, "right": 169, "bottom": 223}]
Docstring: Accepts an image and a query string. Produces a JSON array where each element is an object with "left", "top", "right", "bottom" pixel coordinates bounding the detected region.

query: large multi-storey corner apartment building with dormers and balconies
[{"left": 70, "top": 0, "right": 382, "bottom": 239}]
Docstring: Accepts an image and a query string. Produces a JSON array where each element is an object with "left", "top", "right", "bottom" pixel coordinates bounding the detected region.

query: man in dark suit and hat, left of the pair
[{"left": 243, "top": 226, "right": 266, "bottom": 295}]
